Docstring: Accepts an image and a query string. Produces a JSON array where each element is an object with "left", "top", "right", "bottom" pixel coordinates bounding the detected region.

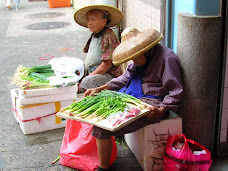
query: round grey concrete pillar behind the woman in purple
[{"left": 177, "top": 13, "right": 222, "bottom": 151}]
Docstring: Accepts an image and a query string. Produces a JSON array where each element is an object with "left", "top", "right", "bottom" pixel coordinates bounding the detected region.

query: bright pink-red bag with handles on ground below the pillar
[{"left": 163, "top": 134, "right": 212, "bottom": 171}]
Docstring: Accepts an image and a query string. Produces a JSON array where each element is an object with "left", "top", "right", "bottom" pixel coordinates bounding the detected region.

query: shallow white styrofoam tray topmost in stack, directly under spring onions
[{"left": 19, "top": 84, "right": 78, "bottom": 97}]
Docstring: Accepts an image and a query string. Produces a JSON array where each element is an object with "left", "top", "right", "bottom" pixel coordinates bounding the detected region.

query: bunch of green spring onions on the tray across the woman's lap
[{"left": 60, "top": 90, "right": 147, "bottom": 120}]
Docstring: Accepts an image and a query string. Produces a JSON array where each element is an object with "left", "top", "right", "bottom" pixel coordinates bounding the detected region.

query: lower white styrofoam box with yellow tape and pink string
[{"left": 11, "top": 89, "right": 74, "bottom": 134}]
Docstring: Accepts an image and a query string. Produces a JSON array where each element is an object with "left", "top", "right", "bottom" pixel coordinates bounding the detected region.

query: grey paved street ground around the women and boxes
[{"left": 0, "top": 0, "right": 142, "bottom": 171}]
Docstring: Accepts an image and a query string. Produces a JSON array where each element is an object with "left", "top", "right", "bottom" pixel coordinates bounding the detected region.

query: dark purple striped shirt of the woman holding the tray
[{"left": 107, "top": 44, "right": 183, "bottom": 112}]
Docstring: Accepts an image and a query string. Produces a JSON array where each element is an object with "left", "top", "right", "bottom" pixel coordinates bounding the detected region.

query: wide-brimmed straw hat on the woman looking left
[{"left": 74, "top": 5, "right": 123, "bottom": 27}]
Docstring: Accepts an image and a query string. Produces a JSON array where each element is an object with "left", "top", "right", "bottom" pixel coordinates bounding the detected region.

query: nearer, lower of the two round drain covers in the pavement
[{"left": 25, "top": 22, "right": 71, "bottom": 30}]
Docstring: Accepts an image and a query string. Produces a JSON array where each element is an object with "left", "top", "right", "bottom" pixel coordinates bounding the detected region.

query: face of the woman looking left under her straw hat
[{"left": 87, "top": 10, "right": 107, "bottom": 33}]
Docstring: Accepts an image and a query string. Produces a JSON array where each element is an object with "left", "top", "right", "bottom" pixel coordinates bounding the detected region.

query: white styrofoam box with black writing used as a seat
[{"left": 124, "top": 113, "right": 182, "bottom": 171}]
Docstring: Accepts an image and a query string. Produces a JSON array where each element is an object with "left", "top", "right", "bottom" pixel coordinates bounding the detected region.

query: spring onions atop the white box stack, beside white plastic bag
[{"left": 11, "top": 64, "right": 55, "bottom": 89}]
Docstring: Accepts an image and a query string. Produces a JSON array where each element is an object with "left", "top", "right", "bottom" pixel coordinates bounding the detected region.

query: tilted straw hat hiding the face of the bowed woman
[{"left": 112, "top": 27, "right": 163, "bottom": 65}]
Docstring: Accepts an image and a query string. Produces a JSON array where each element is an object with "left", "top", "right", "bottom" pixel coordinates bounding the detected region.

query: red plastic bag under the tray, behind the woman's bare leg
[{"left": 60, "top": 120, "right": 117, "bottom": 171}]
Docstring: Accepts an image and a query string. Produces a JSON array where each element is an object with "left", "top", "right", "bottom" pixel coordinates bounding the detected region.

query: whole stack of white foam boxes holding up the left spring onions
[{"left": 11, "top": 86, "right": 77, "bottom": 134}]
